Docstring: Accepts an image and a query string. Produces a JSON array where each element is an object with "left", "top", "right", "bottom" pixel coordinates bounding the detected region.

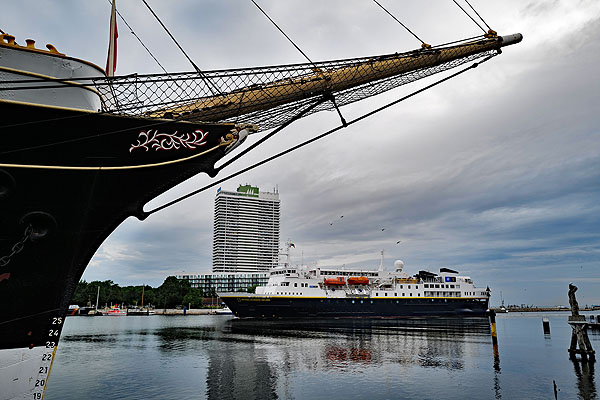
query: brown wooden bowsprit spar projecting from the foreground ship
[{"left": 147, "top": 33, "right": 523, "bottom": 122}]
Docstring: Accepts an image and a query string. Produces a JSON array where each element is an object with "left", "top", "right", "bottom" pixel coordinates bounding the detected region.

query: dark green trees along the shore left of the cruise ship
[{"left": 72, "top": 276, "right": 217, "bottom": 308}]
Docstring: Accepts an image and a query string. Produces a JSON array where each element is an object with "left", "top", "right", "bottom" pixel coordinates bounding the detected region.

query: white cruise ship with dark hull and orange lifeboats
[{"left": 219, "top": 260, "right": 491, "bottom": 318}]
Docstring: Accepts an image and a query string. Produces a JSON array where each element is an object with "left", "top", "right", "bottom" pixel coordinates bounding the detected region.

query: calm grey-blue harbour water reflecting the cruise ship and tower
[{"left": 45, "top": 313, "right": 600, "bottom": 400}]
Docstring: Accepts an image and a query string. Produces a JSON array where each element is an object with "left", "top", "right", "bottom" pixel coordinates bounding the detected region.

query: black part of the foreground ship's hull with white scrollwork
[{"left": 0, "top": 101, "right": 233, "bottom": 349}]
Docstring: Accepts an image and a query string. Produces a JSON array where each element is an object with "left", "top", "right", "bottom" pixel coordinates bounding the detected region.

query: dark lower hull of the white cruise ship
[{"left": 222, "top": 294, "right": 488, "bottom": 318}]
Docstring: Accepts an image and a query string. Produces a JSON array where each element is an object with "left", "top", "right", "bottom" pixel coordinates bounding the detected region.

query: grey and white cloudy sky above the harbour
[{"left": 0, "top": 0, "right": 600, "bottom": 304}]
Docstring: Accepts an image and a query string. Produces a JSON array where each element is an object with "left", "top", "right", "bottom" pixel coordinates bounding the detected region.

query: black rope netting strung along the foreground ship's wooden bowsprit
[{"left": 94, "top": 38, "right": 502, "bottom": 130}]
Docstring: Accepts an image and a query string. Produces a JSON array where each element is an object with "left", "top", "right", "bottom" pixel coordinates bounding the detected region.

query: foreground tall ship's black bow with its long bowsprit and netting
[{"left": 0, "top": 22, "right": 520, "bottom": 399}]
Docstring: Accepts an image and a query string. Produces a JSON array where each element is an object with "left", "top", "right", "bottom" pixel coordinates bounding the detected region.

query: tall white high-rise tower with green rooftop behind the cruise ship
[{"left": 213, "top": 185, "right": 280, "bottom": 273}]
